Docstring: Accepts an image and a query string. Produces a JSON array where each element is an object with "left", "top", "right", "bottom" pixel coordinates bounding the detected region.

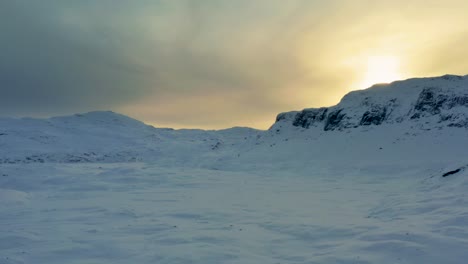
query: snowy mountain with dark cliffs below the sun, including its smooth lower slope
[{"left": 236, "top": 75, "right": 468, "bottom": 173}]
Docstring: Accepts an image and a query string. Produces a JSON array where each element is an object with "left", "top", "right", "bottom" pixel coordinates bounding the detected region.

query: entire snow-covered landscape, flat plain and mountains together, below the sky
[{"left": 0, "top": 76, "right": 468, "bottom": 264}]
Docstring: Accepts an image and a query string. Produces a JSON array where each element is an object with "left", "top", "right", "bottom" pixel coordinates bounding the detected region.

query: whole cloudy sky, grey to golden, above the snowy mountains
[{"left": 0, "top": 0, "right": 468, "bottom": 129}]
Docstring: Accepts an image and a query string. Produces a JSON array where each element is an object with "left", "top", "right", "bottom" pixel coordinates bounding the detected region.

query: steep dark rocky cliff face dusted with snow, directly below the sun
[{"left": 271, "top": 75, "right": 468, "bottom": 131}]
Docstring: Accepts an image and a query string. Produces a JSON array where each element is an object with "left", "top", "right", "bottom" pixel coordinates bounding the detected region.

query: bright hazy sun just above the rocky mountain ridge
[{"left": 359, "top": 56, "right": 402, "bottom": 89}]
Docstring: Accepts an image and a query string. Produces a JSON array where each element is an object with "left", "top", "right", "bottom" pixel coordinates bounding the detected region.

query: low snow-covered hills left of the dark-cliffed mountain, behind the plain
[{"left": 0, "top": 111, "right": 257, "bottom": 163}]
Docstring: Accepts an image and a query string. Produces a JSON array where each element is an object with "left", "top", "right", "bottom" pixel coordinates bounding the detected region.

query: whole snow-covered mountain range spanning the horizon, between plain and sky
[{"left": 0, "top": 75, "right": 468, "bottom": 169}]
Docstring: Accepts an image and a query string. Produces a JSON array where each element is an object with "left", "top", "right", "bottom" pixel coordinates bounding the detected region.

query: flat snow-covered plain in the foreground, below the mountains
[{"left": 0, "top": 163, "right": 468, "bottom": 264}]
